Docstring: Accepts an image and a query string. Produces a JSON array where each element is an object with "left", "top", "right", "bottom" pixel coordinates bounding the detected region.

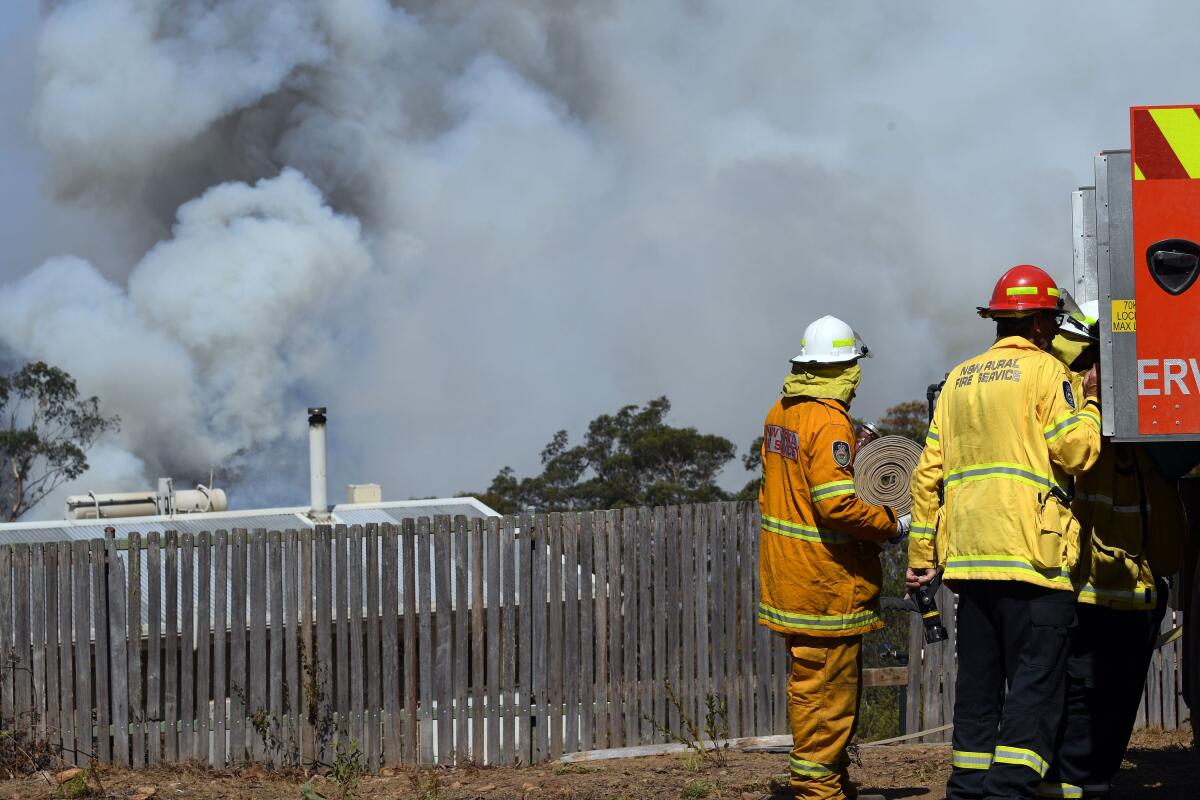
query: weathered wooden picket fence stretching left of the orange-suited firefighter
[{"left": 0, "top": 503, "right": 788, "bottom": 769}]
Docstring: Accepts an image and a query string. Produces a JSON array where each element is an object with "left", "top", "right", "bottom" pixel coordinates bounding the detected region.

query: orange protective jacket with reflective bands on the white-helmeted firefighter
[{"left": 758, "top": 397, "right": 896, "bottom": 637}]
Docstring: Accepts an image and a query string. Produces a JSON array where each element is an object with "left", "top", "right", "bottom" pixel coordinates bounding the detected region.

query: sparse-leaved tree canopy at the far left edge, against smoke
[{"left": 0, "top": 361, "right": 120, "bottom": 522}]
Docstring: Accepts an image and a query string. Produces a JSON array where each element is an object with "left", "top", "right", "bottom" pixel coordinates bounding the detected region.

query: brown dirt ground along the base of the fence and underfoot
[{"left": 0, "top": 730, "right": 1200, "bottom": 800}]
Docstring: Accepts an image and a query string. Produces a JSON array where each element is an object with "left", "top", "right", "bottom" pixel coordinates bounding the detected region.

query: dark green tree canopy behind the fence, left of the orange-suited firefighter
[{"left": 480, "top": 397, "right": 737, "bottom": 513}]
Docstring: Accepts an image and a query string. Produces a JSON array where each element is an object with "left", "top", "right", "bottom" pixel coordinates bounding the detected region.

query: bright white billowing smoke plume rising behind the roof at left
[{"left": 0, "top": 169, "right": 371, "bottom": 520}]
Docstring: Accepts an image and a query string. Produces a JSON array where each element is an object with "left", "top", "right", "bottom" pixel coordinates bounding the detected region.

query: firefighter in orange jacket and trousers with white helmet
[{"left": 758, "top": 317, "right": 908, "bottom": 800}]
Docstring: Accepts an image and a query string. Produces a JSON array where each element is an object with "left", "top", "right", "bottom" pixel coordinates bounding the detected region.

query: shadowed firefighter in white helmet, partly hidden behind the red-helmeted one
[{"left": 1042, "top": 303, "right": 1186, "bottom": 798}]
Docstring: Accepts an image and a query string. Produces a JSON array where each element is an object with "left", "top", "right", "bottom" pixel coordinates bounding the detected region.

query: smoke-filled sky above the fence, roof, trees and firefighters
[{"left": 0, "top": 0, "right": 1200, "bottom": 517}]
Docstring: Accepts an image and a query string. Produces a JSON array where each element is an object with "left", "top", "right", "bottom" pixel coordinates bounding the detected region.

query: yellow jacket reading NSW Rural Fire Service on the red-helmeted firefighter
[{"left": 908, "top": 336, "right": 1100, "bottom": 590}]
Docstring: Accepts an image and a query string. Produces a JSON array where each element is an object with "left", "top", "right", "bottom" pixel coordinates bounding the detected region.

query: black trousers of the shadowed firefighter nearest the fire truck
[{"left": 1050, "top": 579, "right": 1168, "bottom": 798}]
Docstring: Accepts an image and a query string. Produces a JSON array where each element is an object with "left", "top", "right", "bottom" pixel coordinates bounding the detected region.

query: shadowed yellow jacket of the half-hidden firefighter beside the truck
[{"left": 1072, "top": 440, "right": 1187, "bottom": 610}]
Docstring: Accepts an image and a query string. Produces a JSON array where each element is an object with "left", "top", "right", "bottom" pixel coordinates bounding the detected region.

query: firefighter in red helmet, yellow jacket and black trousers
[{"left": 907, "top": 264, "right": 1100, "bottom": 800}]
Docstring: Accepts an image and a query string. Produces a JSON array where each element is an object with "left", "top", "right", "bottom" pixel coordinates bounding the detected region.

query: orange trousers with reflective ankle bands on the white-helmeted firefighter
[{"left": 787, "top": 636, "right": 863, "bottom": 800}]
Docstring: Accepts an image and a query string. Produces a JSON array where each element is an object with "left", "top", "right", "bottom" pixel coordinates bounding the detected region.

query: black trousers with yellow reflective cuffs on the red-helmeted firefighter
[{"left": 946, "top": 581, "right": 1075, "bottom": 800}]
